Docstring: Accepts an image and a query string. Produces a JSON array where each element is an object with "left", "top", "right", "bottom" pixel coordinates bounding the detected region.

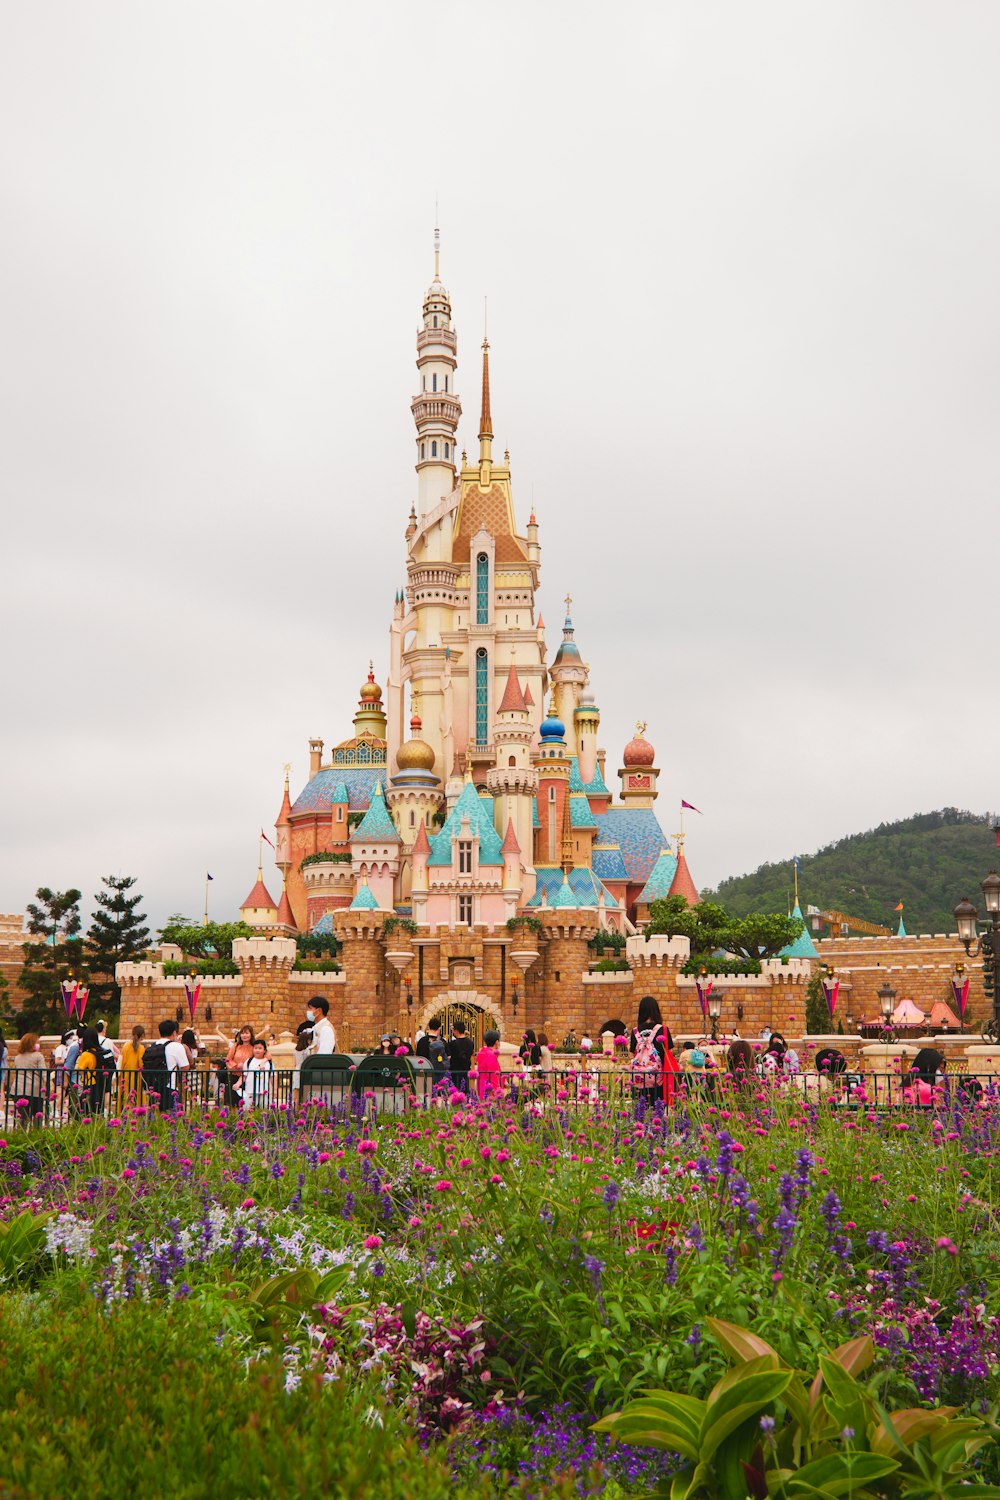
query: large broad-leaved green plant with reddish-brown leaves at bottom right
[{"left": 595, "top": 1319, "right": 1000, "bottom": 1500}]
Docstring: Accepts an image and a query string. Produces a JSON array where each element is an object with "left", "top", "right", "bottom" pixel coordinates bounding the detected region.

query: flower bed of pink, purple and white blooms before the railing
[{"left": 0, "top": 1085, "right": 1000, "bottom": 1496}]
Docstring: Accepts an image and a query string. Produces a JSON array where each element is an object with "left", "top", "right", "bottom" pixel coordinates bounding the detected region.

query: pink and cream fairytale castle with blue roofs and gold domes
[{"left": 118, "top": 240, "right": 941, "bottom": 1047}]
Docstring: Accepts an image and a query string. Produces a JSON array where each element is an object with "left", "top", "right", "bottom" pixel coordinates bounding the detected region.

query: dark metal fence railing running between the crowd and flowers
[{"left": 0, "top": 1058, "right": 1000, "bottom": 1130}]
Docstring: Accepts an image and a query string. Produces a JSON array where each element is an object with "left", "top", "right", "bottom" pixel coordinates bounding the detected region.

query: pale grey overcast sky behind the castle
[{"left": 0, "top": 0, "right": 1000, "bottom": 924}]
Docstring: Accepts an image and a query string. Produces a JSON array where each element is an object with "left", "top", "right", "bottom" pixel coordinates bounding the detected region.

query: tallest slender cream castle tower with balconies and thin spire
[{"left": 409, "top": 228, "right": 462, "bottom": 519}]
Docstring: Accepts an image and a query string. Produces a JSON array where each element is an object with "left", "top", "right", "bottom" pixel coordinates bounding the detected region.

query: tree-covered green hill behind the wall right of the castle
[{"left": 702, "top": 807, "right": 1000, "bottom": 933}]
